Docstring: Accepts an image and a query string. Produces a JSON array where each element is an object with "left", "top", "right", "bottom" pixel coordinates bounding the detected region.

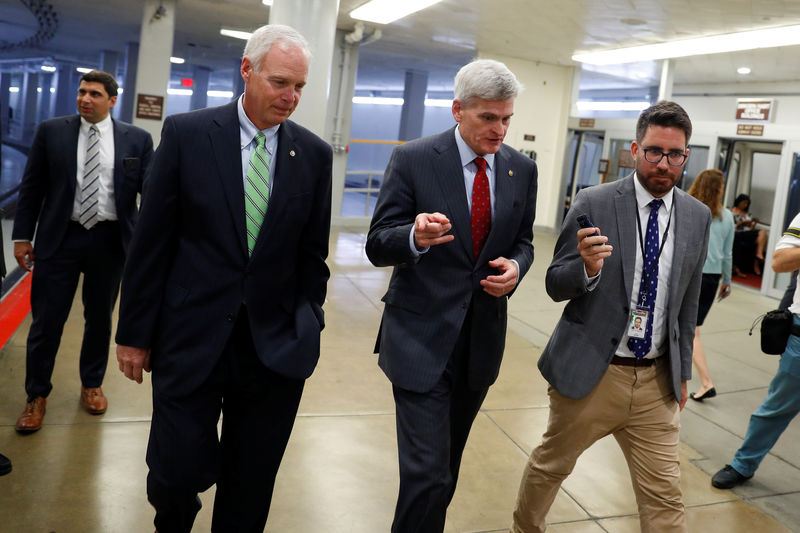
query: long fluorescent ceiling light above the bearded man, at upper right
[{"left": 572, "top": 25, "right": 800, "bottom": 65}]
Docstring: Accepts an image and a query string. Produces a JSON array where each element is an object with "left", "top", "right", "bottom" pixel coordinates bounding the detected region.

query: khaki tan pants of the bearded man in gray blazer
[{"left": 511, "top": 356, "right": 687, "bottom": 533}]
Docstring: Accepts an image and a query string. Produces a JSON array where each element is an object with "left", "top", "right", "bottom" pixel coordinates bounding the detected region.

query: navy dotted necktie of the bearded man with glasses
[{"left": 628, "top": 198, "right": 664, "bottom": 359}]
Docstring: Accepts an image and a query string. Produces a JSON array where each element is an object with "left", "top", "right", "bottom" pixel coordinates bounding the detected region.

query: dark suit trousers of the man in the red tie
[{"left": 392, "top": 320, "right": 489, "bottom": 533}]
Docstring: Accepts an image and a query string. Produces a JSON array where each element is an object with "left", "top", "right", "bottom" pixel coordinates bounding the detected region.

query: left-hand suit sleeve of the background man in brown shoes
[{"left": 11, "top": 122, "right": 49, "bottom": 241}]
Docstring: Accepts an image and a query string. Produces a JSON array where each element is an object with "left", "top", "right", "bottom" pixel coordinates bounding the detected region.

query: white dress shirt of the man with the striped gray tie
[{"left": 72, "top": 115, "right": 117, "bottom": 221}]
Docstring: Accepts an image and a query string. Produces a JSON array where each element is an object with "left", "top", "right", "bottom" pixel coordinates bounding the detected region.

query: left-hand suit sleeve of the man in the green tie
[{"left": 116, "top": 117, "right": 180, "bottom": 348}]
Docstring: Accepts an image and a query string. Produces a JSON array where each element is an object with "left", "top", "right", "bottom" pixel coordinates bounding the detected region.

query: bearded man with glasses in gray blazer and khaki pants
[{"left": 511, "top": 101, "right": 711, "bottom": 533}]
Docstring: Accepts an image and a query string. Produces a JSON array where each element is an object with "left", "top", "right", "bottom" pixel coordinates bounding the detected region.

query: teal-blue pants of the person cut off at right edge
[{"left": 731, "top": 316, "right": 800, "bottom": 477}]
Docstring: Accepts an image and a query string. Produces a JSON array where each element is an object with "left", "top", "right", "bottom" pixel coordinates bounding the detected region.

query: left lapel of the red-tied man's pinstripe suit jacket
[{"left": 433, "top": 129, "right": 472, "bottom": 261}]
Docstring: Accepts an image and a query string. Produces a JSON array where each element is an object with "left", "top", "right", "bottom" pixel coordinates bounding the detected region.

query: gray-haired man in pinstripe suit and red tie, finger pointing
[{"left": 366, "top": 60, "right": 537, "bottom": 533}]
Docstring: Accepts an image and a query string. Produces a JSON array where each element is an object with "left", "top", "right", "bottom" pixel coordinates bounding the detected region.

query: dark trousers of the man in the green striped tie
[{"left": 147, "top": 307, "right": 305, "bottom": 533}]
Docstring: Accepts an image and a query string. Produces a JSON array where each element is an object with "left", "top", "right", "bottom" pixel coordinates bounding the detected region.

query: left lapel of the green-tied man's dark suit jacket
[{"left": 208, "top": 101, "right": 247, "bottom": 255}]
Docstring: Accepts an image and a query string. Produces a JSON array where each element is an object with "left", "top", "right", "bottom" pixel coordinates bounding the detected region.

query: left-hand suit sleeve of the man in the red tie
[{"left": 366, "top": 148, "right": 419, "bottom": 267}]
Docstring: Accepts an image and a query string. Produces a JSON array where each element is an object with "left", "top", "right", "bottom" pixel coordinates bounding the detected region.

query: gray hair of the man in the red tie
[{"left": 453, "top": 59, "right": 522, "bottom": 107}]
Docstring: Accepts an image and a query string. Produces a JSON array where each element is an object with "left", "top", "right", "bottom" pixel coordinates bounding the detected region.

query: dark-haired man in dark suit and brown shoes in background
[{"left": 12, "top": 70, "right": 153, "bottom": 433}]
